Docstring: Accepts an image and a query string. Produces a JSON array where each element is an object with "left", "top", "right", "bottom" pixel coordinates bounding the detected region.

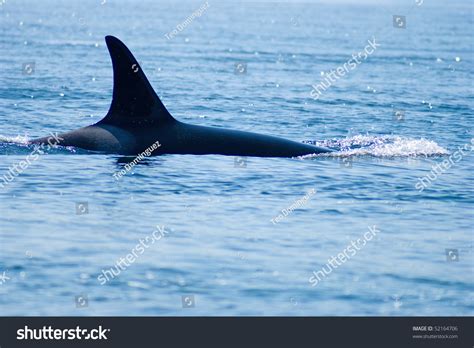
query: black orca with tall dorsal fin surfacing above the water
[{"left": 31, "top": 36, "right": 332, "bottom": 157}]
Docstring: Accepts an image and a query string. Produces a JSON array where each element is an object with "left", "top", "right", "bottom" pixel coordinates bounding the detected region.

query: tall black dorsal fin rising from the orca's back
[{"left": 99, "top": 36, "right": 175, "bottom": 127}]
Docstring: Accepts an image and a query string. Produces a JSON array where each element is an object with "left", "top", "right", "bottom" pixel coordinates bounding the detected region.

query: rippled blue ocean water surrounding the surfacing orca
[{"left": 0, "top": 0, "right": 474, "bottom": 316}]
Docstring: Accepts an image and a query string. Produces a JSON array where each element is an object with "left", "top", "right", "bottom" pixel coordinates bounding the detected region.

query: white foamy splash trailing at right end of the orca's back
[{"left": 306, "top": 135, "right": 449, "bottom": 157}]
